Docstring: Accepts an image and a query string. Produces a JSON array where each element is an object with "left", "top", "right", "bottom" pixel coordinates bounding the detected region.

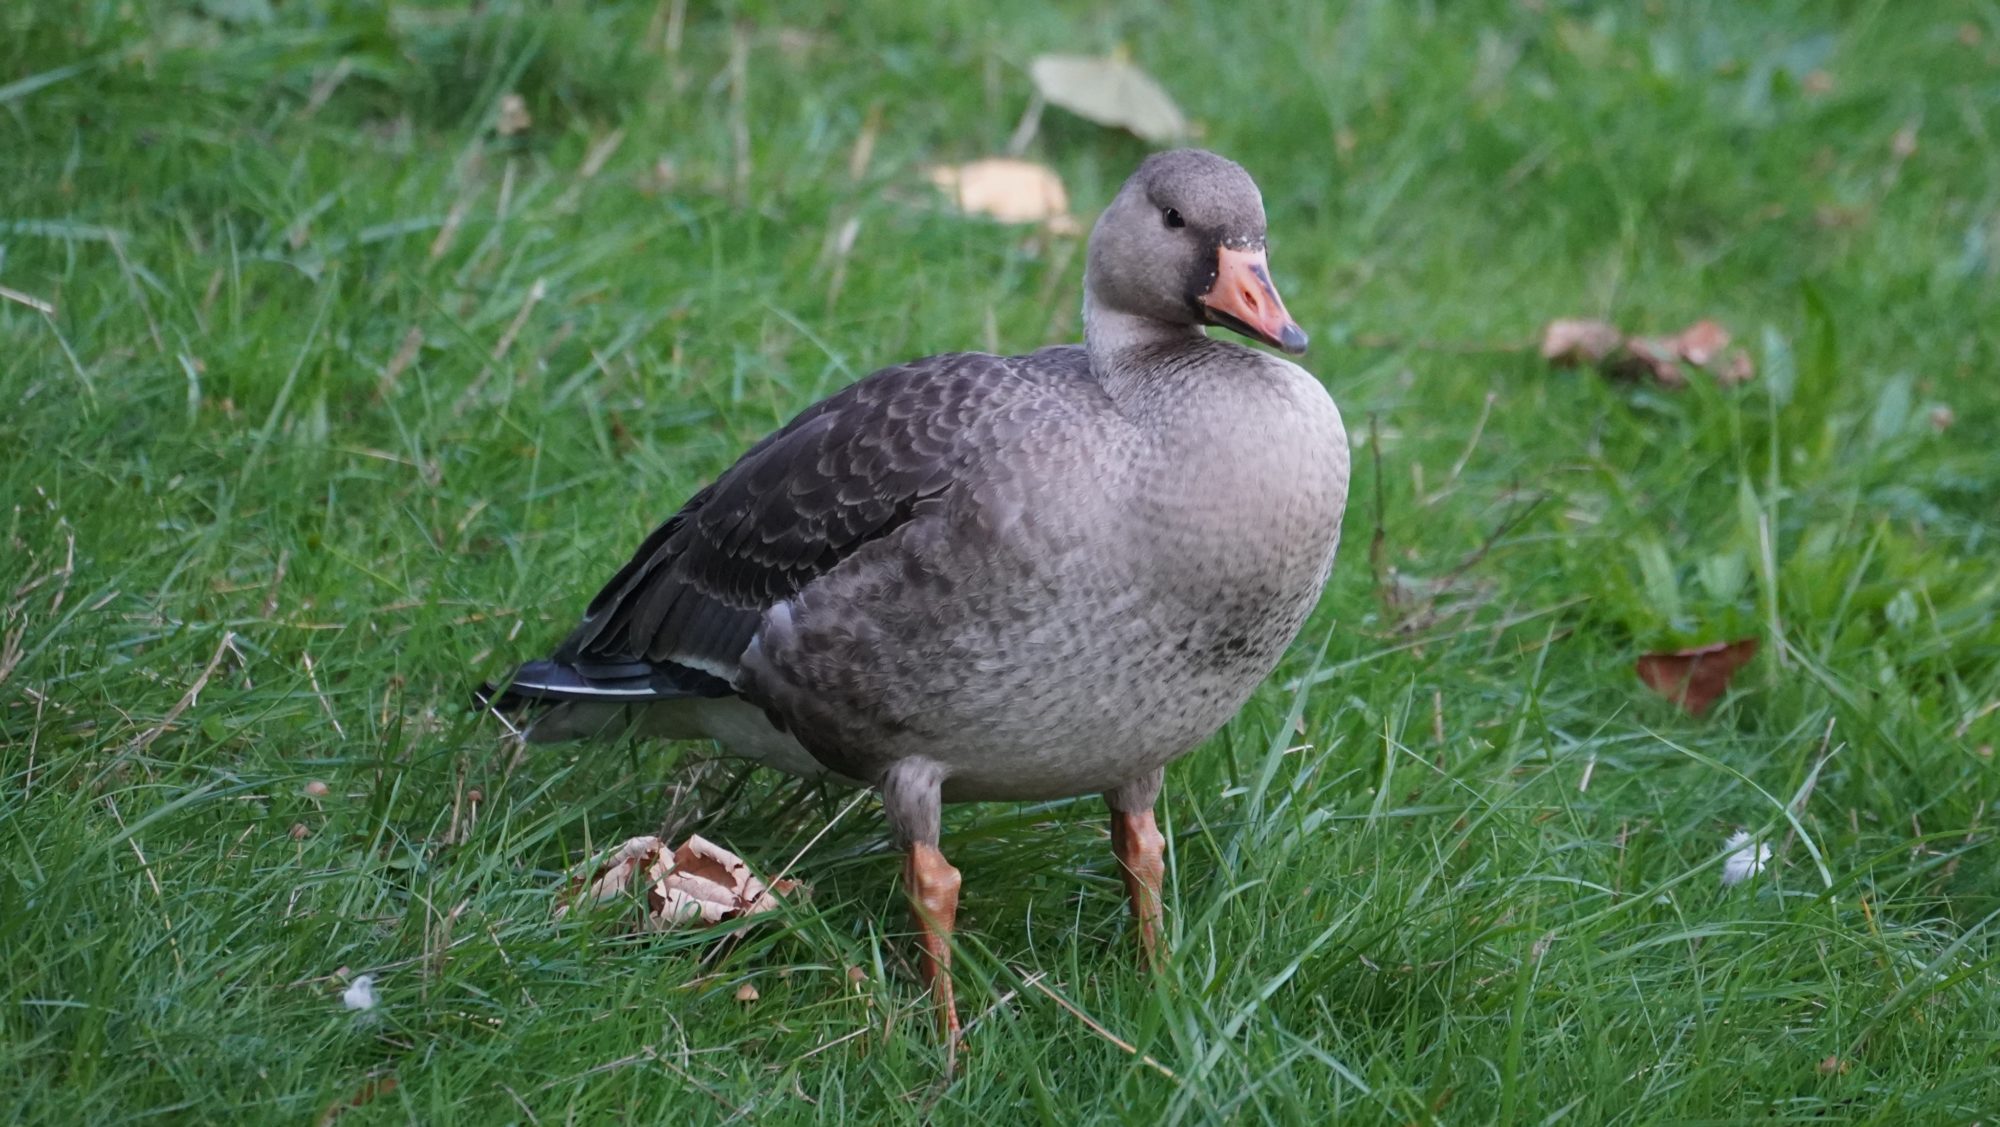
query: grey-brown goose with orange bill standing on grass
[{"left": 480, "top": 150, "right": 1348, "bottom": 1047}]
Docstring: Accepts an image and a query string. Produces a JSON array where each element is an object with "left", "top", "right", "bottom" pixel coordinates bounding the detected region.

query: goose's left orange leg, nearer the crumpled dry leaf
[{"left": 882, "top": 759, "right": 958, "bottom": 1059}]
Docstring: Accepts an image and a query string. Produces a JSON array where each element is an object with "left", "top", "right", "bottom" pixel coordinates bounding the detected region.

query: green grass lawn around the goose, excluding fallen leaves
[{"left": 0, "top": 0, "right": 2000, "bottom": 1123}]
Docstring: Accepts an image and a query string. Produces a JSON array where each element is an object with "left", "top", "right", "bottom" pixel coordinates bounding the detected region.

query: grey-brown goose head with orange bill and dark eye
[{"left": 1084, "top": 148, "right": 1306, "bottom": 356}]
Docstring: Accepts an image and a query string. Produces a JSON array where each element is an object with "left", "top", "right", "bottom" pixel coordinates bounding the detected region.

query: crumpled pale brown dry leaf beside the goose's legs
[{"left": 556, "top": 835, "right": 798, "bottom": 931}]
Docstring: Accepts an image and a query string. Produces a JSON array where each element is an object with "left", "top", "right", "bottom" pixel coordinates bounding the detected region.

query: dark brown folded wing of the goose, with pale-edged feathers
[{"left": 516, "top": 348, "right": 1088, "bottom": 697}]
